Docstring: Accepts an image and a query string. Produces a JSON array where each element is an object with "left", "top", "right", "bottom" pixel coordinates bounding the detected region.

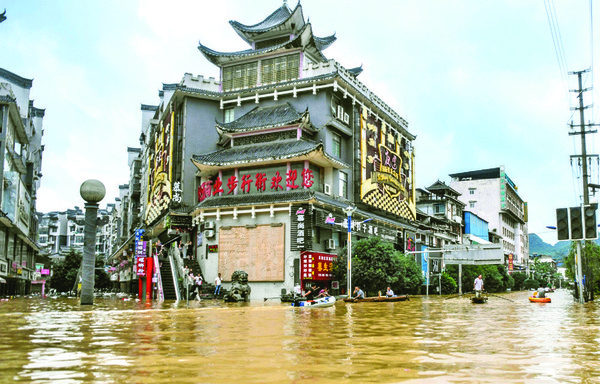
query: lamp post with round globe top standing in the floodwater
[{"left": 79, "top": 180, "right": 106, "bottom": 305}]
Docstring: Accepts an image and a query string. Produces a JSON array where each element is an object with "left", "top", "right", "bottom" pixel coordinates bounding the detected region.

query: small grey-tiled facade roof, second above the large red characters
[{"left": 216, "top": 102, "right": 310, "bottom": 133}]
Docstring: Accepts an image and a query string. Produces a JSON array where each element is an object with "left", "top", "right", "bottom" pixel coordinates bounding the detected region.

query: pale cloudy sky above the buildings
[{"left": 0, "top": 0, "right": 600, "bottom": 243}]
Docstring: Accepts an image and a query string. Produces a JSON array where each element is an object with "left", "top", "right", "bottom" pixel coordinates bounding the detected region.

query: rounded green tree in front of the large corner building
[{"left": 332, "top": 237, "right": 423, "bottom": 296}]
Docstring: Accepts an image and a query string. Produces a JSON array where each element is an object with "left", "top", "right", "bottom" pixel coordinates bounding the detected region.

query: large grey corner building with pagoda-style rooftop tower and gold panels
[{"left": 135, "top": 2, "right": 417, "bottom": 297}]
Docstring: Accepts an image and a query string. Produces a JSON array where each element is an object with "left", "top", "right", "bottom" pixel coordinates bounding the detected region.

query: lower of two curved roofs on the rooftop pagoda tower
[{"left": 198, "top": 23, "right": 336, "bottom": 66}]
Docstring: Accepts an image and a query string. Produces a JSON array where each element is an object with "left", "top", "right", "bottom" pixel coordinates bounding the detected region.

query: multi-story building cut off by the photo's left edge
[{"left": 0, "top": 68, "right": 45, "bottom": 295}]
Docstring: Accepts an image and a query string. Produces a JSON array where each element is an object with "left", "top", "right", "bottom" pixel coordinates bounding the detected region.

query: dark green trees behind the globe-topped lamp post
[{"left": 49, "top": 248, "right": 110, "bottom": 292}]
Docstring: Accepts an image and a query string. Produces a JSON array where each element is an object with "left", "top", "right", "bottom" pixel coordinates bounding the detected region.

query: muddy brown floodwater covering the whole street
[{"left": 0, "top": 290, "right": 600, "bottom": 383}]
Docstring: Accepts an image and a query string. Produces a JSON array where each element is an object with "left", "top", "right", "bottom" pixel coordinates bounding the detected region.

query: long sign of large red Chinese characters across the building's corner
[{"left": 198, "top": 169, "right": 314, "bottom": 202}]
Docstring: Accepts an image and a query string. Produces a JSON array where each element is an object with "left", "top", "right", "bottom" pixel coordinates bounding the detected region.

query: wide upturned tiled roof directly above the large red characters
[{"left": 192, "top": 140, "right": 350, "bottom": 176}]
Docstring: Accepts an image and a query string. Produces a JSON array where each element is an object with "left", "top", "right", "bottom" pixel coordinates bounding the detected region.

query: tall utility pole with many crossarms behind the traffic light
[{"left": 569, "top": 69, "right": 597, "bottom": 304}]
